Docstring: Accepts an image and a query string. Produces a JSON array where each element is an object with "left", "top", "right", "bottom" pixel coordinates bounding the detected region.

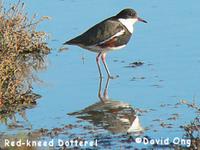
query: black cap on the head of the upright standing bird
[{"left": 115, "top": 8, "right": 137, "bottom": 19}]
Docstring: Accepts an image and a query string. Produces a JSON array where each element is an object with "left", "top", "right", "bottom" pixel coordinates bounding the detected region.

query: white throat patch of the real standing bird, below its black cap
[{"left": 119, "top": 18, "right": 138, "bottom": 33}]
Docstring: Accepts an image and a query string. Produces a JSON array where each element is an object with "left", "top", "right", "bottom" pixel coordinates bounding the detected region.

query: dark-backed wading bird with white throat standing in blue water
[{"left": 63, "top": 8, "right": 147, "bottom": 79}]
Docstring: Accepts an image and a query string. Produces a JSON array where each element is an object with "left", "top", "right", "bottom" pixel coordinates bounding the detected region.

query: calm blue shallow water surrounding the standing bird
[{"left": 0, "top": 0, "right": 200, "bottom": 149}]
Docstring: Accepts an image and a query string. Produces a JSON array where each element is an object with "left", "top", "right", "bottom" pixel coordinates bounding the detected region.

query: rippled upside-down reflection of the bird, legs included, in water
[{"left": 68, "top": 78, "right": 143, "bottom": 133}]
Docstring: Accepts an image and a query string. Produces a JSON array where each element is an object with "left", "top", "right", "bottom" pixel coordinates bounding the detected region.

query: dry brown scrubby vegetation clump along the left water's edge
[{"left": 0, "top": 1, "right": 50, "bottom": 123}]
